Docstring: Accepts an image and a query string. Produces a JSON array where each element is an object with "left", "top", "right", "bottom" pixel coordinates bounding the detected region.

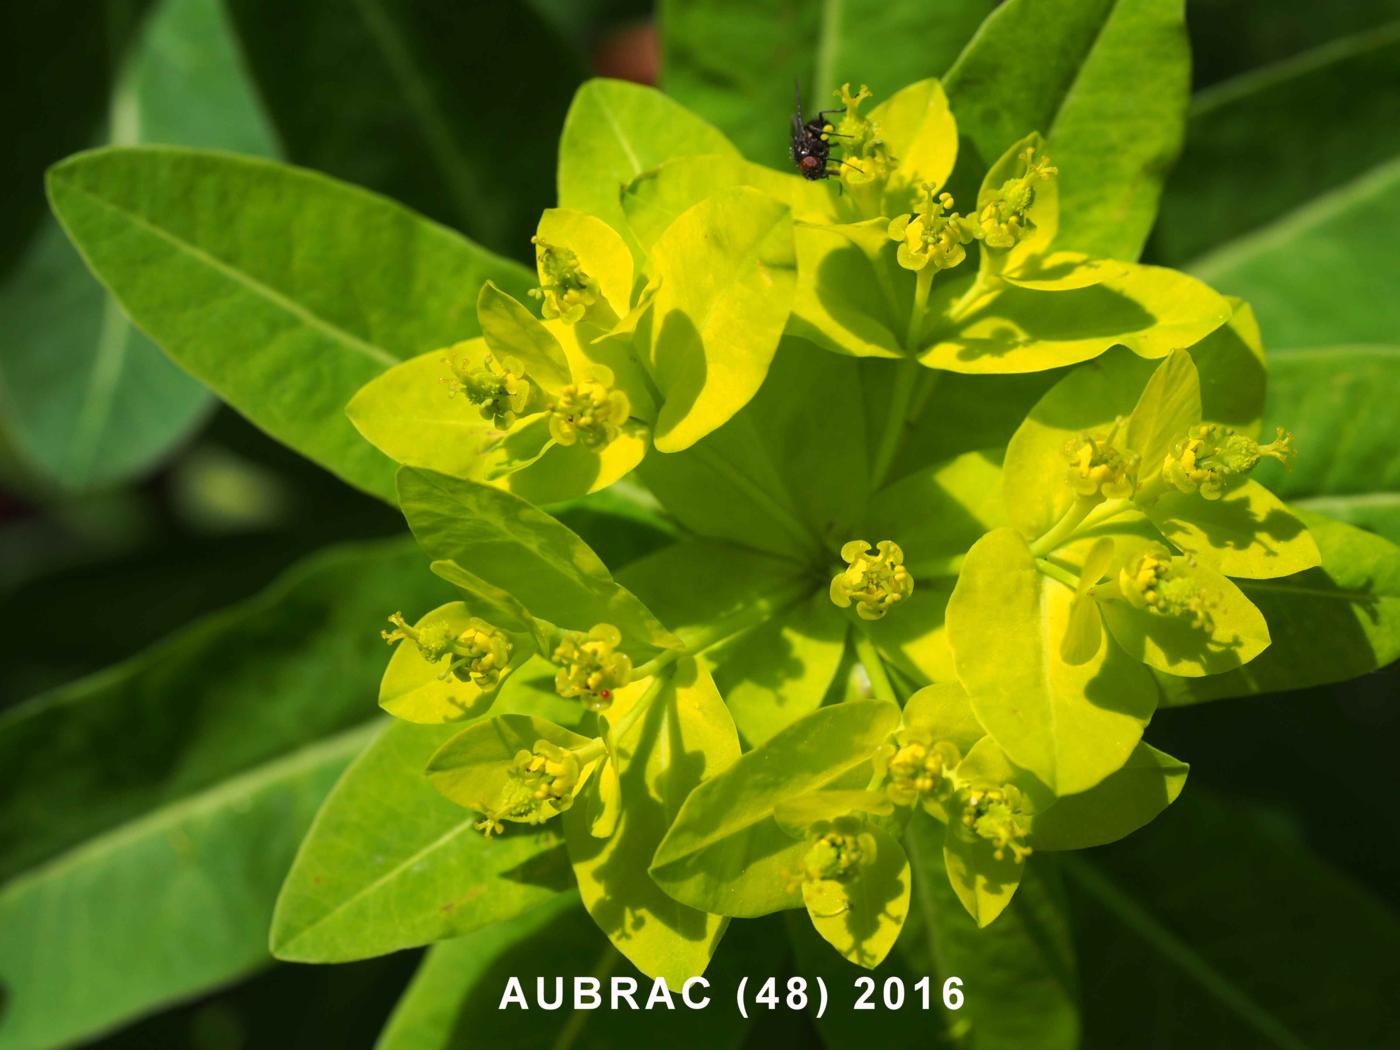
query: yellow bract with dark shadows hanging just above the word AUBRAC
[{"left": 564, "top": 659, "right": 739, "bottom": 988}]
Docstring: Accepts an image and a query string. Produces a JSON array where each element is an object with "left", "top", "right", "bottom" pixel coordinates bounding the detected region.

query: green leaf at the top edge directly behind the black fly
[{"left": 661, "top": 0, "right": 993, "bottom": 167}]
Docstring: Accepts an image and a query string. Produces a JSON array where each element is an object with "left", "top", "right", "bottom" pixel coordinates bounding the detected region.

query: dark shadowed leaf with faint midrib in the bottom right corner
[{"left": 1061, "top": 787, "right": 1400, "bottom": 1050}]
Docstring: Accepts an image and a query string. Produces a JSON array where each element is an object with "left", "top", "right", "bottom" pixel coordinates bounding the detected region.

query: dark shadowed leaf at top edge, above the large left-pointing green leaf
[{"left": 230, "top": 0, "right": 582, "bottom": 256}]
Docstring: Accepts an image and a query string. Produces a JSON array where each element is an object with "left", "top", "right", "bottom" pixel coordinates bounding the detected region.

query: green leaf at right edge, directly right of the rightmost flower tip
[{"left": 1257, "top": 346, "right": 1400, "bottom": 542}]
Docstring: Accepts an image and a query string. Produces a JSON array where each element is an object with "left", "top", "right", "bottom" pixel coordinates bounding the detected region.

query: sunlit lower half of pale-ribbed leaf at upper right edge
[{"left": 1191, "top": 160, "right": 1400, "bottom": 350}]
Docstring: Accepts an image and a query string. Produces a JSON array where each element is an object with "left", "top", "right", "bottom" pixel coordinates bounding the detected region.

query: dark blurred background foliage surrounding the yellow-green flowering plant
[{"left": 0, "top": 0, "right": 1400, "bottom": 1050}]
